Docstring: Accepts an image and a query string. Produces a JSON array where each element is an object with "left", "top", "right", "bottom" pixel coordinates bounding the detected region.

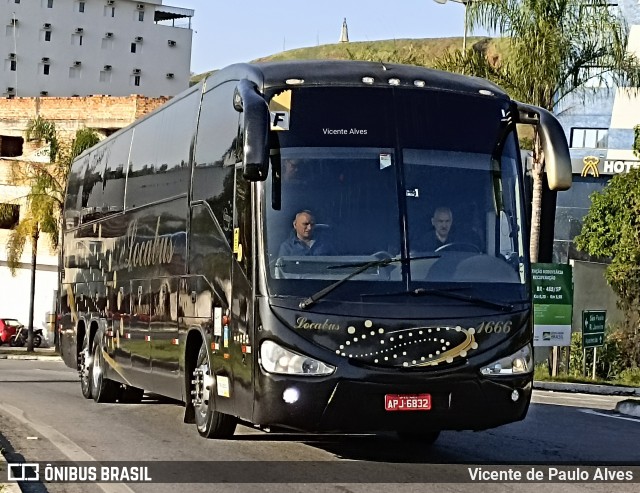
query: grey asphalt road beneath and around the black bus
[{"left": 0, "top": 360, "right": 640, "bottom": 493}]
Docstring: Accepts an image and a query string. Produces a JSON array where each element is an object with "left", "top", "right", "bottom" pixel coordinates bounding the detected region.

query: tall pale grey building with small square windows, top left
[{"left": 0, "top": 0, "right": 194, "bottom": 97}]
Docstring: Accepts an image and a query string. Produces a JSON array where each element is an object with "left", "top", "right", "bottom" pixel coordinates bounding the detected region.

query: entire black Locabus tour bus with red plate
[{"left": 58, "top": 61, "right": 571, "bottom": 442}]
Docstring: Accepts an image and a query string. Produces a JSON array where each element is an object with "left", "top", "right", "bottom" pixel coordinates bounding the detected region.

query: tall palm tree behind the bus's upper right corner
[{"left": 436, "top": 0, "right": 640, "bottom": 262}]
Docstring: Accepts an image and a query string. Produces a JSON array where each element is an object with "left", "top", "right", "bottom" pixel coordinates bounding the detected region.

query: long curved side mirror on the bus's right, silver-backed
[{"left": 516, "top": 102, "right": 571, "bottom": 190}]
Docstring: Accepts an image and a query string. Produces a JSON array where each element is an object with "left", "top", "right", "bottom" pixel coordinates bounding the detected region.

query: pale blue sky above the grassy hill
[{"left": 163, "top": 0, "right": 480, "bottom": 74}]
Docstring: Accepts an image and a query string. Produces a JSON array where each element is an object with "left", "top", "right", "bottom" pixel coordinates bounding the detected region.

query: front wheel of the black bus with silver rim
[{"left": 191, "top": 341, "right": 237, "bottom": 438}]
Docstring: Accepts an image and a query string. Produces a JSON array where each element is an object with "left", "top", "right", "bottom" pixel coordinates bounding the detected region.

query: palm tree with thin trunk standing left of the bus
[{"left": 0, "top": 117, "right": 99, "bottom": 351}]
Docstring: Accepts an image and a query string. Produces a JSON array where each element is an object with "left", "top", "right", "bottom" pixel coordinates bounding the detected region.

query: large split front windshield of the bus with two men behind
[{"left": 263, "top": 86, "right": 527, "bottom": 301}]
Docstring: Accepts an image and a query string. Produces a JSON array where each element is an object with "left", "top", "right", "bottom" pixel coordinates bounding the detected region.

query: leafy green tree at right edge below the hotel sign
[{"left": 575, "top": 169, "right": 640, "bottom": 358}]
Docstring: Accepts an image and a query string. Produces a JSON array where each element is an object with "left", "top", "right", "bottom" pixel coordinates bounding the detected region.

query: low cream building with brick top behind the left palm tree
[{"left": 0, "top": 94, "right": 167, "bottom": 339}]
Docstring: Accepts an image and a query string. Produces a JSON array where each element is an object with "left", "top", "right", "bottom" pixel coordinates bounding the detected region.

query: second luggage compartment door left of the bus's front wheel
[{"left": 125, "top": 280, "right": 153, "bottom": 389}]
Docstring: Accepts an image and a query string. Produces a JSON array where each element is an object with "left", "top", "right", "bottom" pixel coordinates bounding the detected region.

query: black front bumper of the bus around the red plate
[{"left": 254, "top": 374, "right": 533, "bottom": 433}]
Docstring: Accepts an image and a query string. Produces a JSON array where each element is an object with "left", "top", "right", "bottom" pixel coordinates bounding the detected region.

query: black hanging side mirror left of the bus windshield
[{"left": 233, "top": 79, "right": 269, "bottom": 181}]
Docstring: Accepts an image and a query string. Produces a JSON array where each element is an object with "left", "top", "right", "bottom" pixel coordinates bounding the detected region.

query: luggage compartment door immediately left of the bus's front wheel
[{"left": 149, "top": 278, "right": 181, "bottom": 399}]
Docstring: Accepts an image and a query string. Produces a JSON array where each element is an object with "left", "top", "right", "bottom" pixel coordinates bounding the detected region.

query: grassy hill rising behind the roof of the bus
[{"left": 191, "top": 37, "right": 506, "bottom": 84}]
